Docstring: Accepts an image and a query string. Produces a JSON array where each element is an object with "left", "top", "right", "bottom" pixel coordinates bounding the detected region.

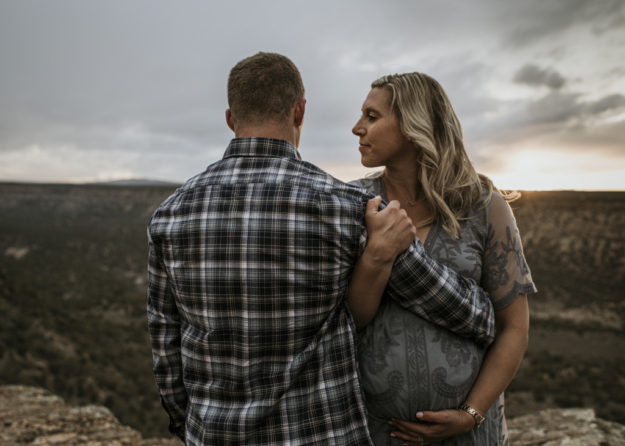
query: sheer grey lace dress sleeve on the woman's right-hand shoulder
[{"left": 482, "top": 193, "right": 537, "bottom": 310}]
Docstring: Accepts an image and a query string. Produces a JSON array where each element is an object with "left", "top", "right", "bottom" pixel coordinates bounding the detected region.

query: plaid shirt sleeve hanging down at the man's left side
[{"left": 147, "top": 225, "right": 188, "bottom": 441}]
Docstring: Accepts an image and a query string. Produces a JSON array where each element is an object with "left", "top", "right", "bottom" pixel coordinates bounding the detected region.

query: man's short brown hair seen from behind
[{"left": 228, "top": 52, "right": 304, "bottom": 122}]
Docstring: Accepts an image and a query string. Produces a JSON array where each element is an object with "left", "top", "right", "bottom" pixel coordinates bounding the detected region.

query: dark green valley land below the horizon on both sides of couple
[{"left": 0, "top": 184, "right": 625, "bottom": 436}]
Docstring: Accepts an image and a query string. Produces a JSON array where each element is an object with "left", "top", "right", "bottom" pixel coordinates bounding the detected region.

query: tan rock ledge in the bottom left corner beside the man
[{"left": 0, "top": 386, "right": 182, "bottom": 446}]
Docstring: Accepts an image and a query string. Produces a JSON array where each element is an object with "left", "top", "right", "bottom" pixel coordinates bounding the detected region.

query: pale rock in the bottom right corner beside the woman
[{"left": 508, "top": 409, "right": 625, "bottom": 446}]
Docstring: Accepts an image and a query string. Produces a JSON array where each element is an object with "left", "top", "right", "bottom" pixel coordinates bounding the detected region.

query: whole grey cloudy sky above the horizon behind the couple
[{"left": 0, "top": 0, "right": 625, "bottom": 190}]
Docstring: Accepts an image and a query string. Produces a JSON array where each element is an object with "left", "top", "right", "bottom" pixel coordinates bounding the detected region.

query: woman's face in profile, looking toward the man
[{"left": 352, "top": 88, "right": 416, "bottom": 167}]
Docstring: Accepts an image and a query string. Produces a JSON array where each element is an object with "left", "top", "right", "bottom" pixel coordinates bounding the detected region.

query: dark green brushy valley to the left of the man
[{"left": 0, "top": 185, "right": 173, "bottom": 436}]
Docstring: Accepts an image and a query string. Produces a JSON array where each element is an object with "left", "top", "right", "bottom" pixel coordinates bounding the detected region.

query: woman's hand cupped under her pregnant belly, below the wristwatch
[{"left": 389, "top": 409, "right": 475, "bottom": 446}]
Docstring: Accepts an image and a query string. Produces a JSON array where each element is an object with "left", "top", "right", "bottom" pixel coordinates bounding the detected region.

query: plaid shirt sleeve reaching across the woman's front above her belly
[{"left": 386, "top": 239, "right": 495, "bottom": 345}]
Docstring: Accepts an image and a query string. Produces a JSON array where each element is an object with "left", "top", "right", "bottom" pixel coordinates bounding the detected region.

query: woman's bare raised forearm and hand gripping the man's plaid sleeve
[{"left": 347, "top": 197, "right": 417, "bottom": 329}]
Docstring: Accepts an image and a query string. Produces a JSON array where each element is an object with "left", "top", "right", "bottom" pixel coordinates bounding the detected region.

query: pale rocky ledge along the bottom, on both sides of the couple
[{"left": 0, "top": 386, "right": 625, "bottom": 446}]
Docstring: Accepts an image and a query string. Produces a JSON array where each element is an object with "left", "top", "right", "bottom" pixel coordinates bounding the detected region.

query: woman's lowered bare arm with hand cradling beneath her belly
[{"left": 390, "top": 294, "right": 529, "bottom": 445}]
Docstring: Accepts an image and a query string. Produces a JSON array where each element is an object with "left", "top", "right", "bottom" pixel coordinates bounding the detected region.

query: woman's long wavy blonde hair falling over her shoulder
[{"left": 371, "top": 73, "right": 518, "bottom": 238}]
